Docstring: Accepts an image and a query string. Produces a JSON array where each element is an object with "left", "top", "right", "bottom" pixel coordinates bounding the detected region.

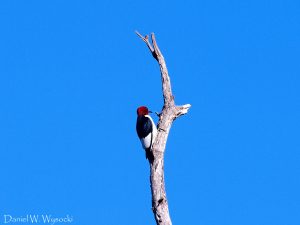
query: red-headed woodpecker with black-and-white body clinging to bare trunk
[{"left": 136, "top": 106, "right": 157, "bottom": 161}]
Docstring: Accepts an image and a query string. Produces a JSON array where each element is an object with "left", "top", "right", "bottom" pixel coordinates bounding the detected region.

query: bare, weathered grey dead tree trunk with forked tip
[{"left": 136, "top": 32, "right": 191, "bottom": 225}]
